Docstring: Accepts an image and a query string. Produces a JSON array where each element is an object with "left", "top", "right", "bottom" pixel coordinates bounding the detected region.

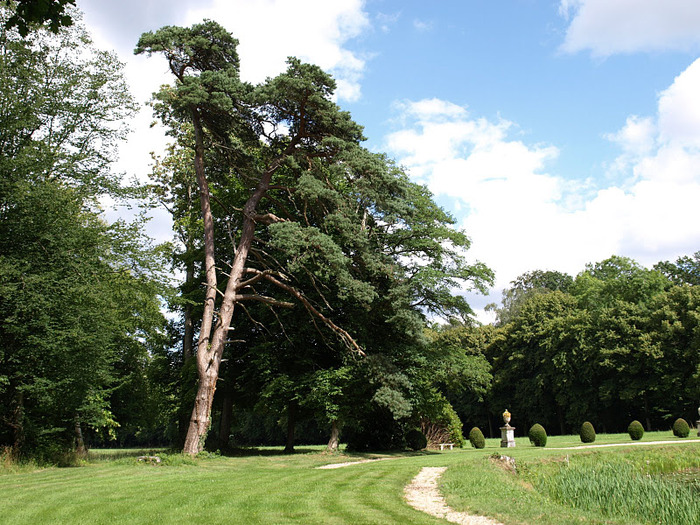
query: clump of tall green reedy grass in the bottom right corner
[{"left": 538, "top": 462, "right": 700, "bottom": 525}]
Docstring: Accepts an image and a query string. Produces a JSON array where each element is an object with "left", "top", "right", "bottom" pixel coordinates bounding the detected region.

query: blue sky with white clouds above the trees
[{"left": 77, "top": 0, "right": 700, "bottom": 322}]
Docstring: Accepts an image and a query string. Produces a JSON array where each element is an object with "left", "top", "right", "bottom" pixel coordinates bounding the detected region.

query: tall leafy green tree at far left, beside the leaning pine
[{"left": 0, "top": 8, "right": 165, "bottom": 458}]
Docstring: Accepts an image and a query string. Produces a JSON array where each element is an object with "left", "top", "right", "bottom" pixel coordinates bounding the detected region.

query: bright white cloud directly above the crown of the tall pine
[{"left": 185, "top": 0, "right": 370, "bottom": 101}]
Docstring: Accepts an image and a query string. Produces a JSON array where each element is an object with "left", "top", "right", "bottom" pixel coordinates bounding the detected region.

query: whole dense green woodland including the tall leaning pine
[{"left": 0, "top": 7, "right": 700, "bottom": 460}]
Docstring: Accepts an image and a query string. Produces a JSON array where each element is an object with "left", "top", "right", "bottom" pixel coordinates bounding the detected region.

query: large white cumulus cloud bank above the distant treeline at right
[{"left": 385, "top": 59, "right": 700, "bottom": 319}]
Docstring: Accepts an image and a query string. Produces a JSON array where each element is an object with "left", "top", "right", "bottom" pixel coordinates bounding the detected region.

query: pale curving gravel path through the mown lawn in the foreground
[{"left": 404, "top": 467, "right": 502, "bottom": 525}]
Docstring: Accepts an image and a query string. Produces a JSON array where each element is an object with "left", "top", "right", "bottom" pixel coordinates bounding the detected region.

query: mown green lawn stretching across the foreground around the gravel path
[{"left": 0, "top": 432, "right": 700, "bottom": 524}]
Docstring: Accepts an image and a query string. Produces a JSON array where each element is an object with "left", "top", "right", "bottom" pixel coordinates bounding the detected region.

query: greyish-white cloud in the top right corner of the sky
[{"left": 559, "top": 0, "right": 700, "bottom": 56}]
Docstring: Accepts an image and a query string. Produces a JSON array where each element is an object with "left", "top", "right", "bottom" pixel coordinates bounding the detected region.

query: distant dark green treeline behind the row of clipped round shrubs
[{"left": 435, "top": 252, "right": 700, "bottom": 435}]
